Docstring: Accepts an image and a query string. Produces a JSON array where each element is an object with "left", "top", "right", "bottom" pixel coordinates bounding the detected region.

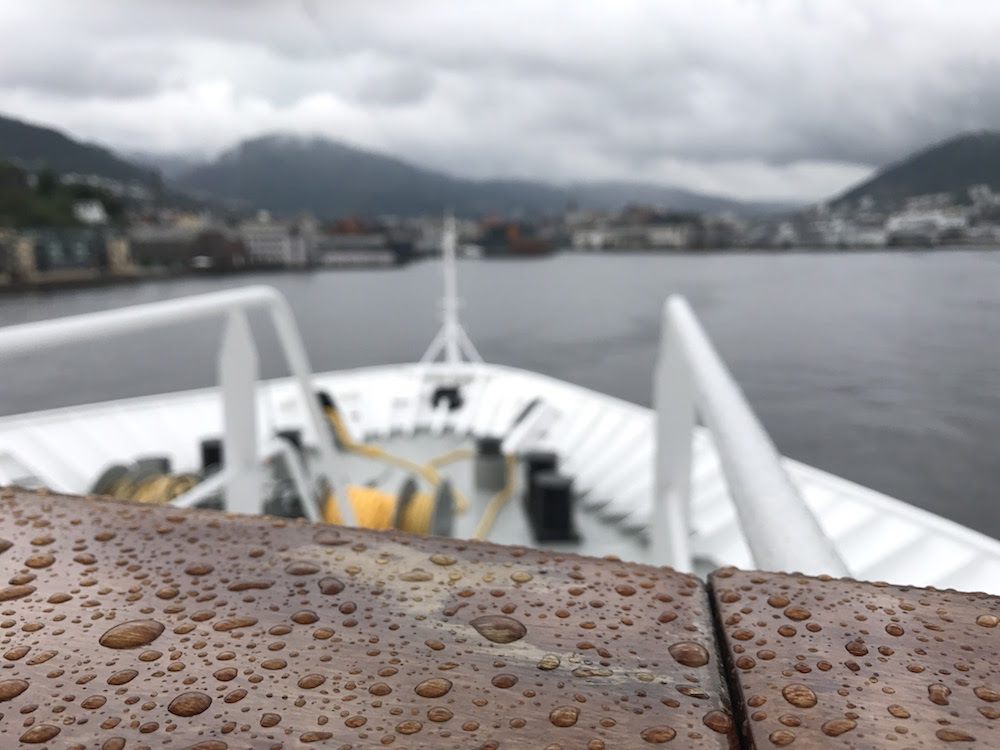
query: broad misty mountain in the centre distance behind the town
[{"left": 176, "top": 135, "right": 788, "bottom": 218}]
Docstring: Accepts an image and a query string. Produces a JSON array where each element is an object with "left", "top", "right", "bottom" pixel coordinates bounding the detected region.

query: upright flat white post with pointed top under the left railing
[{"left": 218, "top": 310, "right": 263, "bottom": 514}]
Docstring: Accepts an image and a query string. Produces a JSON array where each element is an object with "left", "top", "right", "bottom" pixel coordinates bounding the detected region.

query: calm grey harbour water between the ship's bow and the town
[{"left": 0, "top": 250, "right": 1000, "bottom": 537}]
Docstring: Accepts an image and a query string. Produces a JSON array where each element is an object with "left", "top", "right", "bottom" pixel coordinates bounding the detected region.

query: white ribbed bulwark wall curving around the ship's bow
[{"left": 0, "top": 364, "right": 1000, "bottom": 593}]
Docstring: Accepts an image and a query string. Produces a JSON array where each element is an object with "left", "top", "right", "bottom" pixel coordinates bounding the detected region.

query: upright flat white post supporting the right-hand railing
[{"left": 651, "top": 307, "right": 695, "bottom": 573}]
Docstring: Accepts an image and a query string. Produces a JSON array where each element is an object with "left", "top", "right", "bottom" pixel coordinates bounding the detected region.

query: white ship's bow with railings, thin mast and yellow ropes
[{"left": 0, "top": 216, "right": 1000, "bottom": 593}]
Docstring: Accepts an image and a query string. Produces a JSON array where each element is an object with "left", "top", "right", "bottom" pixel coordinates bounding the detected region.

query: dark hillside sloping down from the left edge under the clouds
[{"left": 0, "top": 115, "right": 160, "bottom": 186}]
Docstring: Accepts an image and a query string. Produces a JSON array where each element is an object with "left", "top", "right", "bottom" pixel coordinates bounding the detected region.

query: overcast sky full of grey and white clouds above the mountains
[{"left": 0, "top": 0, "right": 1000, "bottom": 200}]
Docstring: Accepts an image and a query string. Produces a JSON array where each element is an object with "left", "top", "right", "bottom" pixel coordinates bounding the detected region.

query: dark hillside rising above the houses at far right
[{"left": 831, "top": 131, "right": 1000, "bottom": 209}]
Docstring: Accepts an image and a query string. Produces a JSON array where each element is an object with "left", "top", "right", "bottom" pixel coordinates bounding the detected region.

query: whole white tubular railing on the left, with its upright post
[{"left": 0, "top": 286, "right": 354, "bottom": 524}]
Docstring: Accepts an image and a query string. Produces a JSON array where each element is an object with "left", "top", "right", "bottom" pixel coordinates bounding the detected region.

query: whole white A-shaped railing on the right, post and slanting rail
[{"left": 651, "top": 296, "right": 848, "bottom": 576}]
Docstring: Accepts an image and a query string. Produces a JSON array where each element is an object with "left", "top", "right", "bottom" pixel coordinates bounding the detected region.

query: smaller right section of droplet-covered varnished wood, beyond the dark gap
[{"left": 711, "top": 570, "right": 1000, "bottom": 750}]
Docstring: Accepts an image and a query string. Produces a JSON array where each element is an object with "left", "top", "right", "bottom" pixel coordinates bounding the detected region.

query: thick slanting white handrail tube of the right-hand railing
[{"left": 657, "top": 297, "right": 848, "bottom": 576}]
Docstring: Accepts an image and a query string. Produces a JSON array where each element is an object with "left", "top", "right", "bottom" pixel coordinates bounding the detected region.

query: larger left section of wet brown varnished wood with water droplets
[{"left": 0, "top": 490, "right": 736, "bottom": 750}]
